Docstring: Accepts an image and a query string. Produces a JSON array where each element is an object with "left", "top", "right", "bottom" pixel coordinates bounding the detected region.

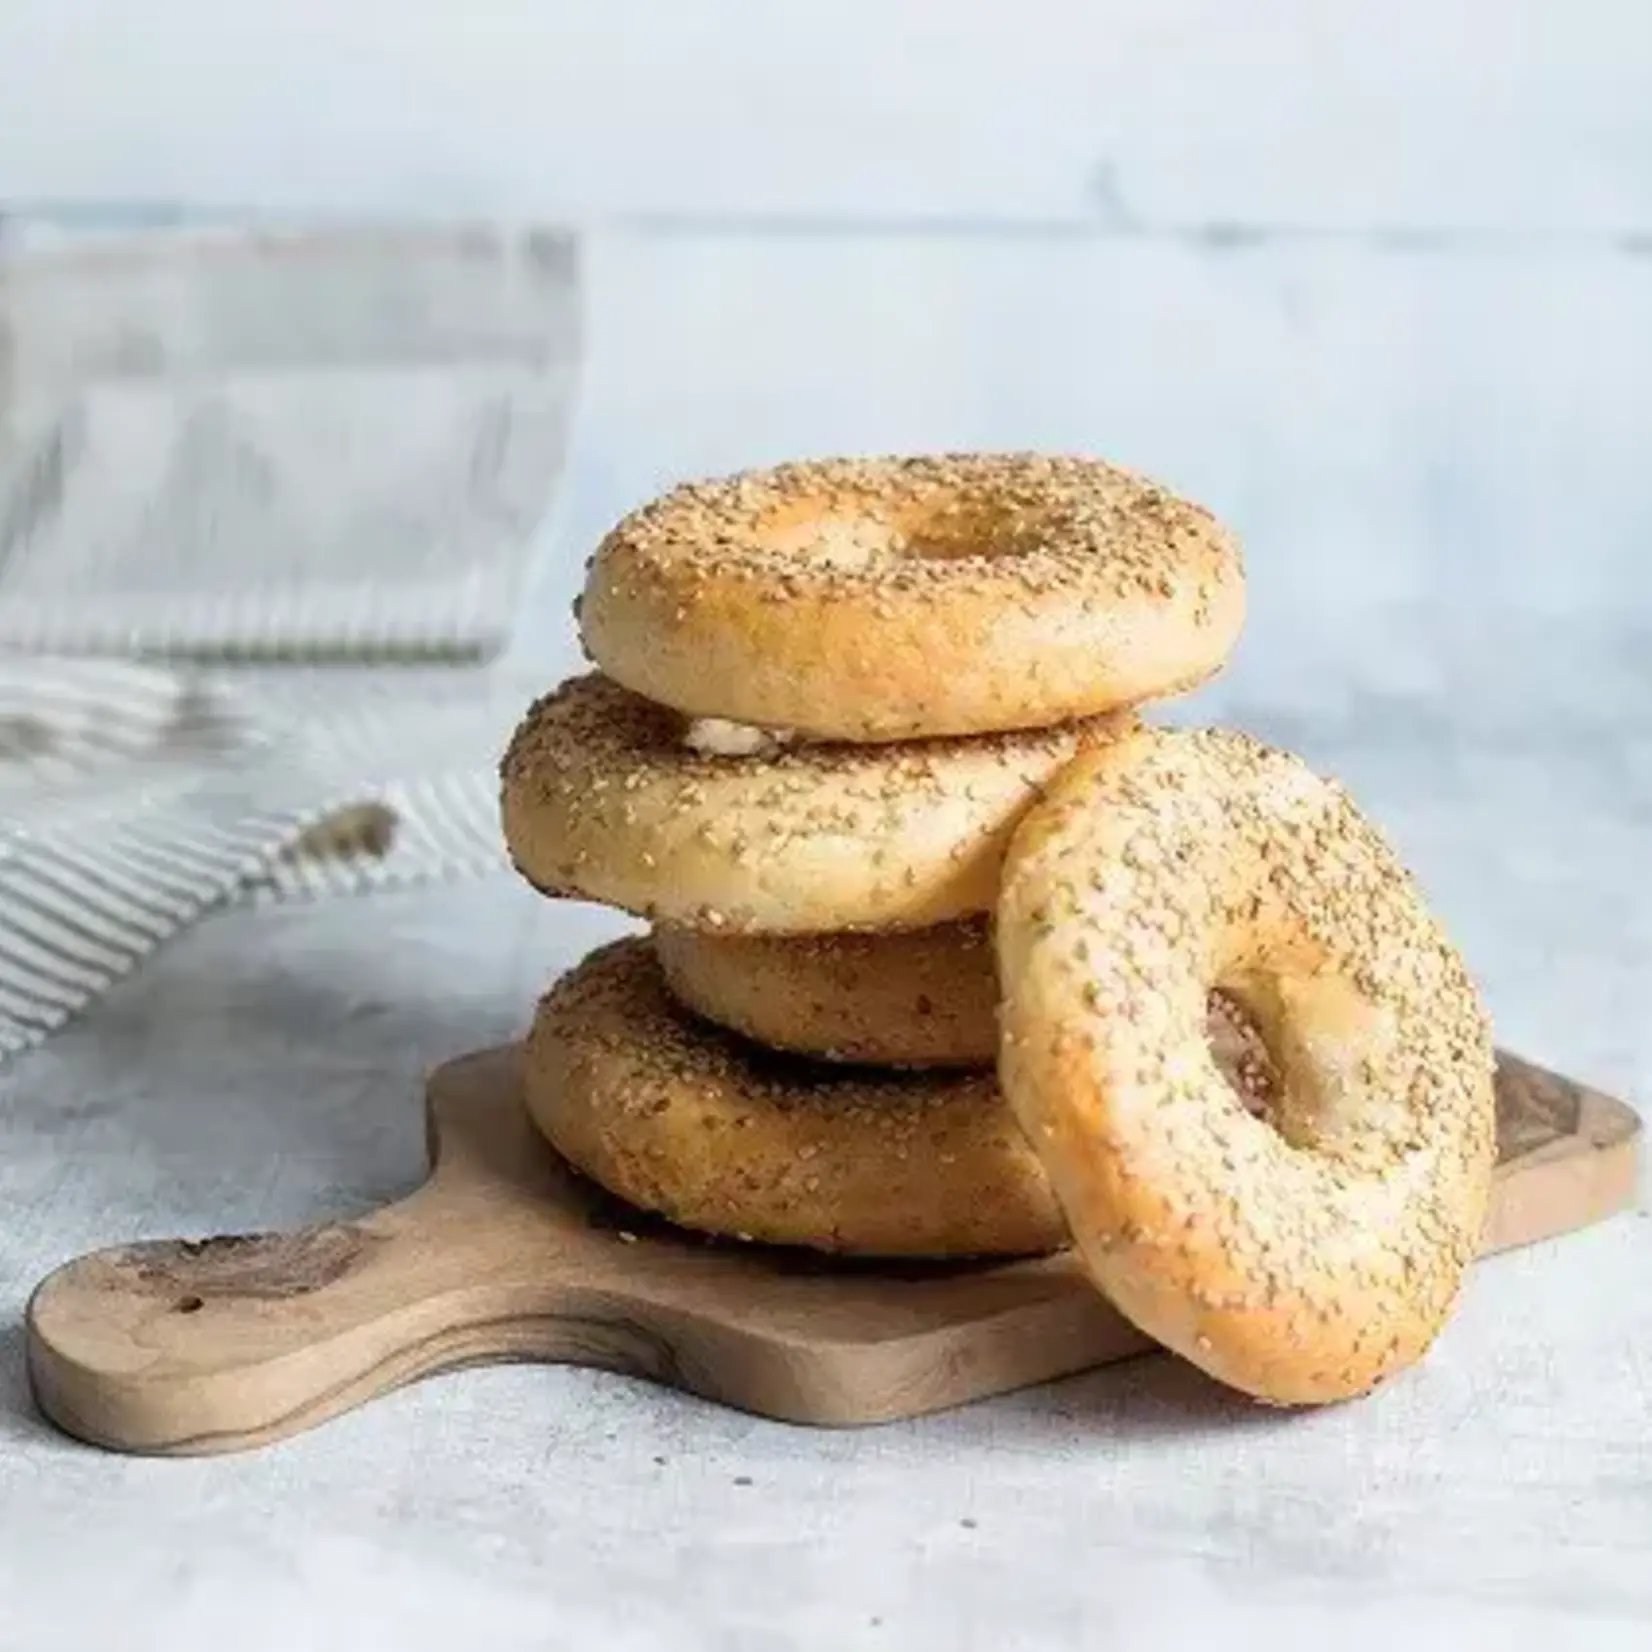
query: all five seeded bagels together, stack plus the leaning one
[{"left": 502, "top": 454, "right": 1495, "bottom": 1403}]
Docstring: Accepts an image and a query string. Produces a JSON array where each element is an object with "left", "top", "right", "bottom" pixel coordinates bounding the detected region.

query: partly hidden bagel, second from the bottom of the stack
[{"left": 654, "top": 919, "right": 1274, "bottom": 1083}]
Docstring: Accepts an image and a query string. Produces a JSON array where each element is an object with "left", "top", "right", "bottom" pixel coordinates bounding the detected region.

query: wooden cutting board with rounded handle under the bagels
[{"left": 28, "top": 1047, "right": 1640, "bottom": 1455}]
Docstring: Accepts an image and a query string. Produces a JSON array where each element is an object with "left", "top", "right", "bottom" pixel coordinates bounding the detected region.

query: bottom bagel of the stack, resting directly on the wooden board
[{"left": 524, "top": 940, "right": 1067, "bottom": 1257}]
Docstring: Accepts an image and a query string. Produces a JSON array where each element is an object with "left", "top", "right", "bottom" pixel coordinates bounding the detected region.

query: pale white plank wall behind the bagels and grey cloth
[{"left": 0, "top": 0, "right": 1652, "bottom": 649}]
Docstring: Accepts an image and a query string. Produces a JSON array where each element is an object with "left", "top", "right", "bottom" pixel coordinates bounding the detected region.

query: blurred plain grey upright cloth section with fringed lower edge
[{"left": 0, "top": 220, "right": 582, "bottom": 661}]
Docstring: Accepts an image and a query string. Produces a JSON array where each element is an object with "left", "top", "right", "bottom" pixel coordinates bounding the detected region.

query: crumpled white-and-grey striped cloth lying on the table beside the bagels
[{"left": 0, "top": 654, "right": 539, "bottom": 1057}]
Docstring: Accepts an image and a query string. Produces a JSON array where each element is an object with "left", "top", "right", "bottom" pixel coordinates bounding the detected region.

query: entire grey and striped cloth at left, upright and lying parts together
[{"left": 0, "top": 220, "right": 580, "bottom": 1054}]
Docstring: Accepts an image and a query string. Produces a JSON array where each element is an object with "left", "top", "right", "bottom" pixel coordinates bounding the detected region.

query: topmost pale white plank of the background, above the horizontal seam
[{"left": 0, "top": 0, "right": 1652, "bottom": 232}]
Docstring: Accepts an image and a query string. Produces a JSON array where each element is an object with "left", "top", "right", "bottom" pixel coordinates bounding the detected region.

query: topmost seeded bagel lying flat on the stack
[{"left": 578, "top": 454, "right": 1244, "bottom": 742}]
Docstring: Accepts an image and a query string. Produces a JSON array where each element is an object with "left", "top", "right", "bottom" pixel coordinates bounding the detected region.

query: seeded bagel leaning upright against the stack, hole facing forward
[{"left": 996, "top": 732, "right": 1495, "bottom": 1404}]
